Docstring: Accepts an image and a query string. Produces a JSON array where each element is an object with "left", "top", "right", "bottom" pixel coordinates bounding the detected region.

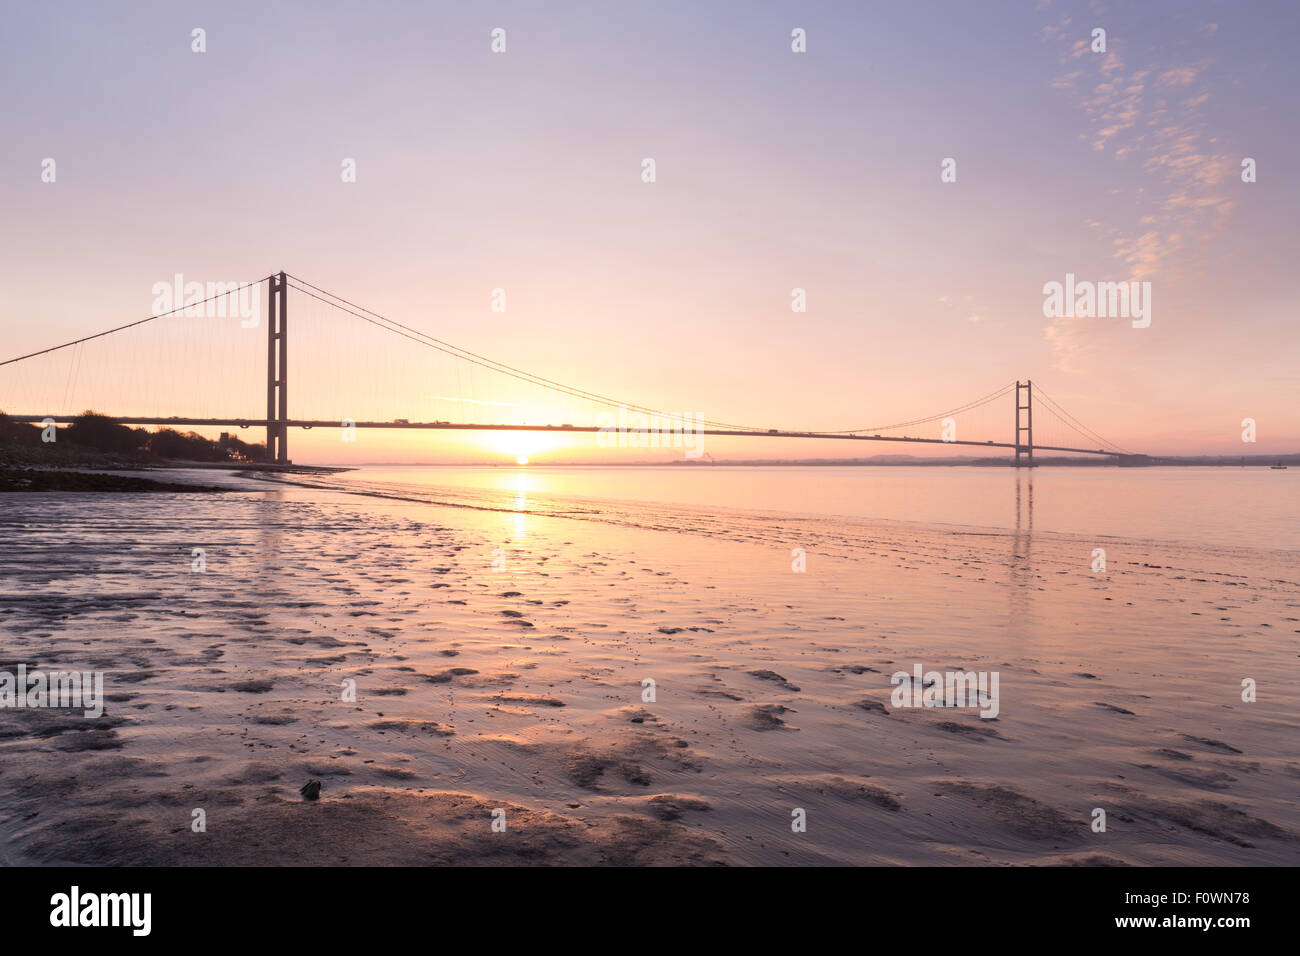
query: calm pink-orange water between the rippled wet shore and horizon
[{"left": 341, "top": 466, "right": 1300, "bottom": 550}]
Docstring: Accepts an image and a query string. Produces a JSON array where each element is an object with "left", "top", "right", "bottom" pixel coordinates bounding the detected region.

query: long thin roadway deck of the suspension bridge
[{"left": 7, "top": 415, "right": 1141, "bottom": 459}]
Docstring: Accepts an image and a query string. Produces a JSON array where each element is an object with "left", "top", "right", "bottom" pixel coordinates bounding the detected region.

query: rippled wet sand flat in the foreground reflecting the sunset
[{"left": 0, "top": 479, "right": 1300, "bottom": 865}]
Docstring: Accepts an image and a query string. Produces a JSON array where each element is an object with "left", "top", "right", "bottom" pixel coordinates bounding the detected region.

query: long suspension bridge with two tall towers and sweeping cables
[{"left": 0, "top": 272, "right": 1147, "bottom": 467}]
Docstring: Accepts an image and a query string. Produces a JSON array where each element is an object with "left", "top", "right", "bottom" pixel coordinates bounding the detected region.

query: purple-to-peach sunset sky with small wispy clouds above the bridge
[{"left": 0, "top": 0, "right": 1300, "bottom": 463}]
